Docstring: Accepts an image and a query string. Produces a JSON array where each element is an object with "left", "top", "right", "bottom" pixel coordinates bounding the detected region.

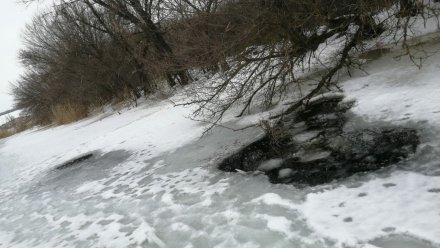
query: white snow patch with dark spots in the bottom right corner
[{"left": 301, "top": 173, "right": 440, "bottom": 246}]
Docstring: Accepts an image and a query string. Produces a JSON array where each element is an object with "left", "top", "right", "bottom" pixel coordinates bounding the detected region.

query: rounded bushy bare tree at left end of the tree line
[{"left": 13, "top": 5, "right": 161, "bottom": 122}]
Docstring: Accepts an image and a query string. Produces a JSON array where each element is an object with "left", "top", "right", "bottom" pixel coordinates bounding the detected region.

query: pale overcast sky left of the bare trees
[{"left": 0, "top": 0, "right": 42, "bottom": 112}]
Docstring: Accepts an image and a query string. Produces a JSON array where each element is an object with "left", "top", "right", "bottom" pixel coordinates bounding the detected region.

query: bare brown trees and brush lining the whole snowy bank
[{"left": 13, "top": 0, "right": 435, "bottom": 124}]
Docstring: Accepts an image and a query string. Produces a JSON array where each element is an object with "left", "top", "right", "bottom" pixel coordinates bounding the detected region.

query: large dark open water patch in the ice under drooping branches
[{"left": 219, "top": 92, "right": 420, "bottom": 185}]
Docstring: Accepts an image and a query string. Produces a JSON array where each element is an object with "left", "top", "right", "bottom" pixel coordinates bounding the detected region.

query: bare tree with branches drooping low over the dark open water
[{"left": 174, "top": 0, "right": 436, "bottom": 131}]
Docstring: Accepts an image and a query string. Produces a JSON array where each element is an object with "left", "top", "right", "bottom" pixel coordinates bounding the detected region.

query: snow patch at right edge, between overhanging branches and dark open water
[{"left": 345, "top": 47, "right": 440, "bottom": 123}]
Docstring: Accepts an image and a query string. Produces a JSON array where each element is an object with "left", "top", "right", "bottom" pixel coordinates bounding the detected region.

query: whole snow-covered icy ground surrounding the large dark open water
[{"left": 0, "top": 44, "right": 440, "bottom": 248}]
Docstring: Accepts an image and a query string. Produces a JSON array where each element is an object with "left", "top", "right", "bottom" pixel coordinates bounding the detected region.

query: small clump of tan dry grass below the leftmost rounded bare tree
[{"left": 52, "top": 103, "right": 87, "bottom": 125}]
